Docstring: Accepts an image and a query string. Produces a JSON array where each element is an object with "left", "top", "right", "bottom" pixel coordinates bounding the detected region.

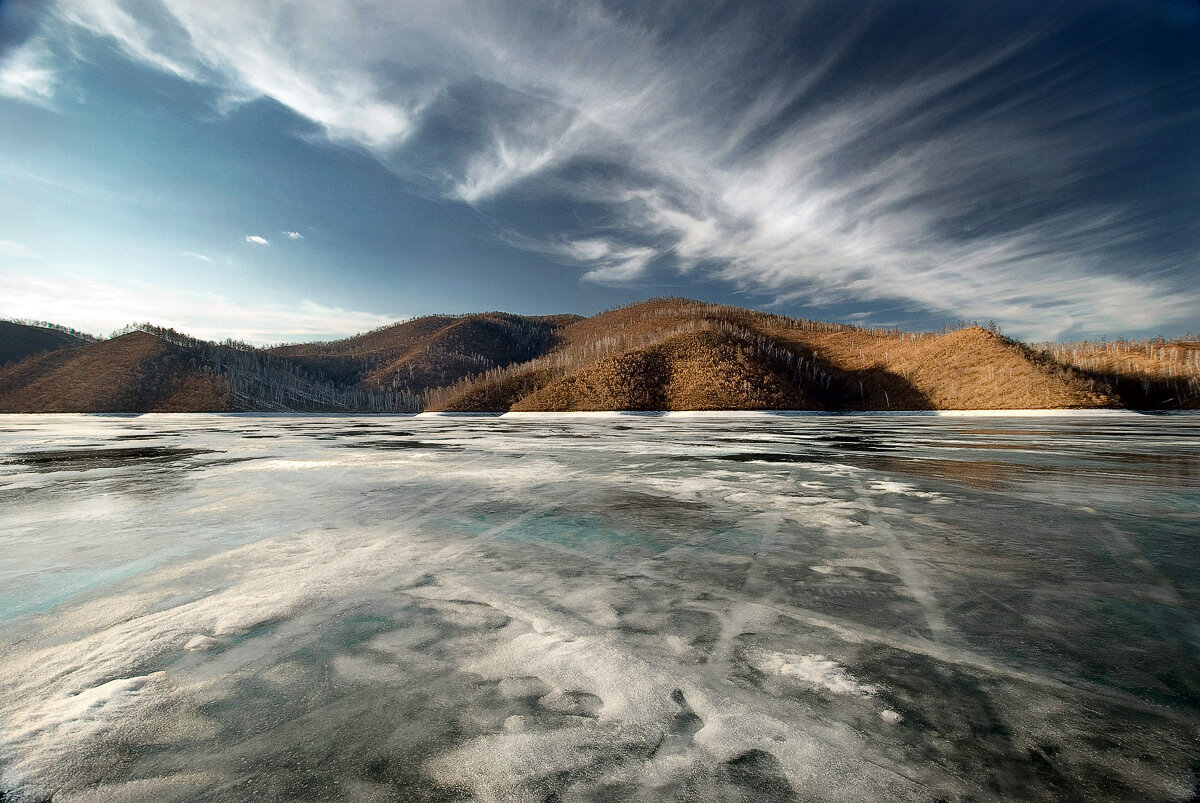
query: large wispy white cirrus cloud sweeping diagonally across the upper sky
[{"left": 42, "top": 0, "right": 1200, "bottom": 337}]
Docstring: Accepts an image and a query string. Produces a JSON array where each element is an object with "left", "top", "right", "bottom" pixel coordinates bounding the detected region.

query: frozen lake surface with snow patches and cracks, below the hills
[{"left": 0, "top": 414, "right": 1200, "bottom": 803}]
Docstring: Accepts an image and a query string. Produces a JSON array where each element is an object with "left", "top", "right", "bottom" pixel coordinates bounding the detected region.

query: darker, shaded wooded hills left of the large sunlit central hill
[{"left": 0, "top": 313, "right": 577, "bottom": 413}]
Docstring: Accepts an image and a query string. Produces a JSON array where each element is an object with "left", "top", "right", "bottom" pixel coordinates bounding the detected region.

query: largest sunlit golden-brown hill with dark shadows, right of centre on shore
[{"left": 428, "top": 299, "right": 1116, "bottom": 411}]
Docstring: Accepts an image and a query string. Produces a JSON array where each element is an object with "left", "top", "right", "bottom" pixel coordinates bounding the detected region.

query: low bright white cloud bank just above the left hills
[{"left": 0, "top": 271, "right": 402, "bottom": 344}]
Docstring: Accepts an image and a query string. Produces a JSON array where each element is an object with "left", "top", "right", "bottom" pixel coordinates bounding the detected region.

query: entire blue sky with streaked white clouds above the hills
[{"left": 0, "top": 0, "right": 1200, "bottom": 343}]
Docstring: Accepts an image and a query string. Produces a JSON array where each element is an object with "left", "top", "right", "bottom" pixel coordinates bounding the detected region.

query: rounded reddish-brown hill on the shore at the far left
[{"left": 0, "top": 331, "right": 230, "bottom": 413}]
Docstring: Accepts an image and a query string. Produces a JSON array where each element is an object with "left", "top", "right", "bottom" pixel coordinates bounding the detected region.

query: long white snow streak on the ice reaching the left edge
[{"left": 0, "top": 532, "right": 417, "bottom": 785}]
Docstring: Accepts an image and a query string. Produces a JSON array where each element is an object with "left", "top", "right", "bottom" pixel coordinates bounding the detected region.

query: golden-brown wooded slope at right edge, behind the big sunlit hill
[{"left": 1039, "top": 338, "right": 1200, "bottom": 409}]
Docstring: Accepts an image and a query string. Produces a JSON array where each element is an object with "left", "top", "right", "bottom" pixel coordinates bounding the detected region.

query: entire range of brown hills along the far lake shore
[{"left": 0, "top": 299, "right": 1200, "bottom": 412}]
